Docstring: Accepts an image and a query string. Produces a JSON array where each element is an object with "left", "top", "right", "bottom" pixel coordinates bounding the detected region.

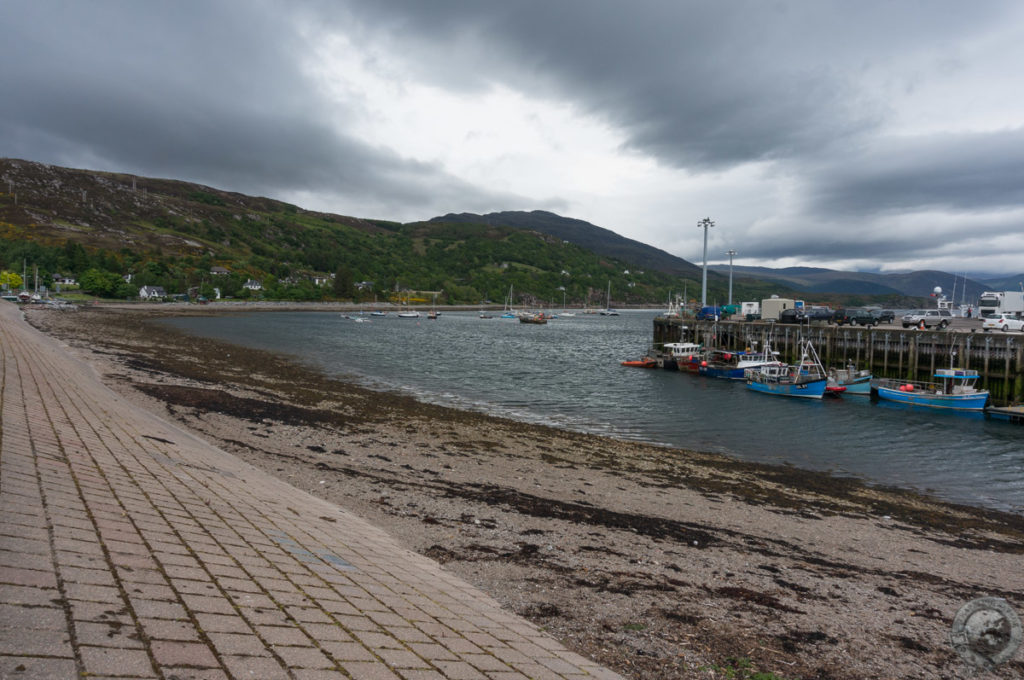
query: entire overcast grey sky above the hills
[{"left": 0, "top": 0, "right": 1024, "bottom": 273}]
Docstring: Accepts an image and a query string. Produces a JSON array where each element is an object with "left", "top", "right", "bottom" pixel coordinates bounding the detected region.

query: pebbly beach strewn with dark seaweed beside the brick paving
[{"left": 27, "top": 305, "right": 1024, "bottom": 680}]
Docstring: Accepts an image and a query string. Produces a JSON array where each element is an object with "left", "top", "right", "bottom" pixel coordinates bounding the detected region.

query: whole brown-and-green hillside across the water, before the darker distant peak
[{"left": 0, "top": 159, "right": 777, "bottom": 306}]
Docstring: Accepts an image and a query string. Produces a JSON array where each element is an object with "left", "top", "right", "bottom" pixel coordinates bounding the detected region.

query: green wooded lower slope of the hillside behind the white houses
[{"left": 0, "top": 199, "right": 753, "bottom": 305}]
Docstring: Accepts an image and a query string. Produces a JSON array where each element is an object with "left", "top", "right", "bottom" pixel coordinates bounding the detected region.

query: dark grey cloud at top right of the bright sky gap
[{"left": 339, "top": 0, "right": 993, "bottom": 169}]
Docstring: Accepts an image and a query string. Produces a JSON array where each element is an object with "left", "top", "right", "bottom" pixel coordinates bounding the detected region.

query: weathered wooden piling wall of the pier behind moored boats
[{"left": 653, "top": 316, "right": 1024, "bottom": 407}]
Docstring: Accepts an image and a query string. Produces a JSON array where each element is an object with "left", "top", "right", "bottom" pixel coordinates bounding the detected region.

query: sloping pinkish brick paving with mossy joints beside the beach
[{"left": 0, "top": 302, "right": 618, "bottom": 680}]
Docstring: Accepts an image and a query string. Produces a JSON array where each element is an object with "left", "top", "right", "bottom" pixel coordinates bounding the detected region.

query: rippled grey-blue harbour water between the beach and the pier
[{"left": 167, "top": 311, "right": 1024, "bottom": 513}]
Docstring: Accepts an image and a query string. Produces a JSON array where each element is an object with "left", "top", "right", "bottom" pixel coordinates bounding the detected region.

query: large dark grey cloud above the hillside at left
[{"left": 0, "top": 1, "right": 512, "bottom": 215}]
